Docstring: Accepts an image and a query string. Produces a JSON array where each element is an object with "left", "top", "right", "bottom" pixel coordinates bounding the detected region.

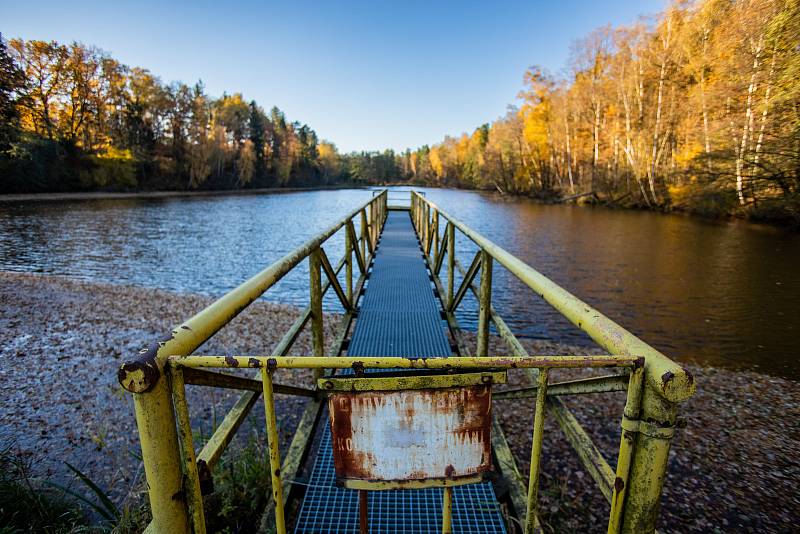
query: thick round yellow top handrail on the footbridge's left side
[{"left": 118, "top": 190, "right": 386, "bottom": 393}]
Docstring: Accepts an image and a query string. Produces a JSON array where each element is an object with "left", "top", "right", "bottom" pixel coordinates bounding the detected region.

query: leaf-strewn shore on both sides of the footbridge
[{"left": 0, "top": 272, "right": 800, "bottom": 532}]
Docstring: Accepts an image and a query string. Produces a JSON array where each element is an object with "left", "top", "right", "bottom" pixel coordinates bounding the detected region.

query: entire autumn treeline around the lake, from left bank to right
[{"left": 0, "top": 0, "right": 800, "bottom": 222}]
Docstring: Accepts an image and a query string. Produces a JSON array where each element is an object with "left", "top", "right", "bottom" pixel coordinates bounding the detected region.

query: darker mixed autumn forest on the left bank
[{"left": 0, "top": 34, "right": 346, "bottom": 192}]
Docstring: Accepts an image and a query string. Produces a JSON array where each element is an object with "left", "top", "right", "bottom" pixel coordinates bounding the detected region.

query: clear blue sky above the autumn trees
[{"left": 0, "top": 0, "right": 665, "bottom": 152}]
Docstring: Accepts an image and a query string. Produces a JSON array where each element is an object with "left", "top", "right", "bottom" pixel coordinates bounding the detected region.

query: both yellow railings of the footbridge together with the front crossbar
[{"left": 119, "top": 191, "right": 694, "bottom": 533}]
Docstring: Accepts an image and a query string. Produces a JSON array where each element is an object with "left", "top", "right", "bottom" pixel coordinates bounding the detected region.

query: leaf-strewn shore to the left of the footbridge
[{"left": 0, "top": 272, "right": 340, "bottom": 508}]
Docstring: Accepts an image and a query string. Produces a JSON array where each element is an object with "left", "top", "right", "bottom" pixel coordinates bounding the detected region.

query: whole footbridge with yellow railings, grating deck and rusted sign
[{"left": 118, "top": 190, "right": 695, "bottom": 533}]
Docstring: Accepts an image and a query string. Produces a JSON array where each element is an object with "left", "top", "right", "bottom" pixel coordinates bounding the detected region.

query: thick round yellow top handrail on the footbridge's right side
[{"left": 412, "top": 191, "right": 695, "bottom": 402}]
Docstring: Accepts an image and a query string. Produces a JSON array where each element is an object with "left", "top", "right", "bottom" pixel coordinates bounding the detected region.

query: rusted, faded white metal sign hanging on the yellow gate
[{"left": 328, "top": 385, "right": 492, "bottom": 487}]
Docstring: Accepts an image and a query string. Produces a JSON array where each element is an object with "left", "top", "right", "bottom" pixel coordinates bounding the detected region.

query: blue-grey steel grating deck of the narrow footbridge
[{"left": 295, "top": 211, "right": 506, "bottom": 534}]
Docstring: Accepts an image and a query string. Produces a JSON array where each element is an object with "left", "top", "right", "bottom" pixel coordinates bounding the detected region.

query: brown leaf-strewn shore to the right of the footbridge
[{"left": 476, "top": 340, "right": 800, "bottom": 533}]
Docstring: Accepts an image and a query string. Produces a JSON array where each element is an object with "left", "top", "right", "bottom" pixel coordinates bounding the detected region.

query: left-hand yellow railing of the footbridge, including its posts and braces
[{"left": 118, "top": 191, "right": 387, "bottom": 533}]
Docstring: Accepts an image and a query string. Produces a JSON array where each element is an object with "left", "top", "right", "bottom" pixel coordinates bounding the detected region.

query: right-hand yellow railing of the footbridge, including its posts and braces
[{"left": 411, "top": 192, "right": 695, "bottom": 532}]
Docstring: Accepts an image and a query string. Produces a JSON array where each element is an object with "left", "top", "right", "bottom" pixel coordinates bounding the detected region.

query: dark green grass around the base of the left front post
[{"left": 0, "top": 430, "right": 270, "bottom": 534}]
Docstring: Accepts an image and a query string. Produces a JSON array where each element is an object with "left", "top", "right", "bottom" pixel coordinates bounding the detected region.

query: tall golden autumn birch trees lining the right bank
[{"left": 398, "top": 0, "right": 800, "bottom": 223}]
